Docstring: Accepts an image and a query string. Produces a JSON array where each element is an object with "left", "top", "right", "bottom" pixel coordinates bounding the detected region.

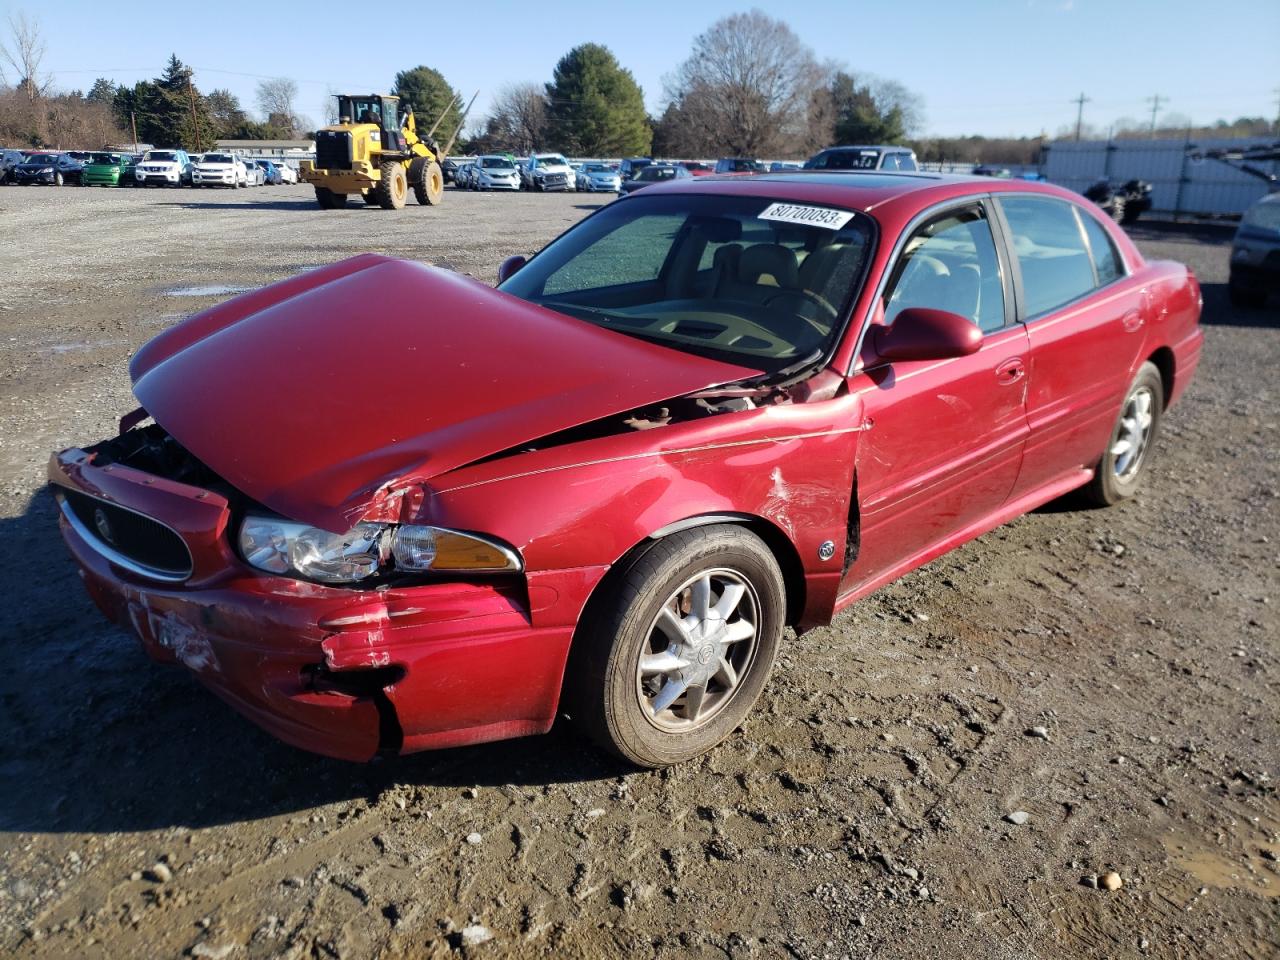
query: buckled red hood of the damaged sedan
[{"left": 129, "top": 255, "right": 759, "bottom": 531}]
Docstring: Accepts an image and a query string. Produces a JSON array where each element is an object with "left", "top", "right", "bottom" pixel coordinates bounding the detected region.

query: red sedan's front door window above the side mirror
[{"left": 884, "top": 204, "right": 1005, "bottom": 332}]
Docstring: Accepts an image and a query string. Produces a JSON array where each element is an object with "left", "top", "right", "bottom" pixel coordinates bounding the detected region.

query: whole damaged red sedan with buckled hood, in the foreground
[{"left": 49, "top": 173, "right": 1202, "bottom": 765}]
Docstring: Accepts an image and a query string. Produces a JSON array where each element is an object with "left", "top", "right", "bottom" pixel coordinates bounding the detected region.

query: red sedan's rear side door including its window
[{"left": 997, "top": 193, "right": 1147, "bottom": 495}]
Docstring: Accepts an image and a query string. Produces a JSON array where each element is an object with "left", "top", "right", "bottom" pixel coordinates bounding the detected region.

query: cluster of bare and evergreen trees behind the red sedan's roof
[{"left": 466, "top": 10, "right": 923, "bottom": 159}]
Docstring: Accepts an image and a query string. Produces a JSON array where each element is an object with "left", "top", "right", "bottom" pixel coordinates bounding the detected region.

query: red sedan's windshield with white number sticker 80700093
[{"left": 500, "top": 195, "right": 872, "bottom": 372}]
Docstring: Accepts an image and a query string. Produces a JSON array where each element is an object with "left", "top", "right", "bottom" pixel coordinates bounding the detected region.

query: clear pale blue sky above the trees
[{"left": 20, "top": 0, "right": 1280, "bottom": 136}]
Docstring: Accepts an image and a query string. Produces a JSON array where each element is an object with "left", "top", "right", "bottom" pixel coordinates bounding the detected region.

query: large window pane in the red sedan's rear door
[{"left": 1000, "top": 197, "right": 1094, "bottom": 317}]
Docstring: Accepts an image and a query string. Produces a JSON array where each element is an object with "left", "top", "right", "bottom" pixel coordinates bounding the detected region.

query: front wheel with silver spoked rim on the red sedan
[{"left": 566, "top": 525, "right": 786, "bottom": 768}]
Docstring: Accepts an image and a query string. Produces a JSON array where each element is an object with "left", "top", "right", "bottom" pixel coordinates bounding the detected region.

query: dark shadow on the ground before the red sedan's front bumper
[{"left": 0, "top": 490, "right": 630, "bottom": 832}]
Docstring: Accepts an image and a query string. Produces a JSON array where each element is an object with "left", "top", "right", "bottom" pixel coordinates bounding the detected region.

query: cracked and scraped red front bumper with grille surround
[{"left": 49, "top": 449, "right": 593, "bottom": 760}]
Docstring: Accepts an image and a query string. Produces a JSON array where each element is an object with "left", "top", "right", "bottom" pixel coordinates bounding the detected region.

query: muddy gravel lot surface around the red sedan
[{"left": 0, "top": 181, "right": 1280, "bottom": 960}]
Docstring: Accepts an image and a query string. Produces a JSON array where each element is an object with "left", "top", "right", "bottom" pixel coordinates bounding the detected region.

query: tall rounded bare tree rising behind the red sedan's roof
[{"left": 667, "top": 10, "right": 826, "bottom": 156}]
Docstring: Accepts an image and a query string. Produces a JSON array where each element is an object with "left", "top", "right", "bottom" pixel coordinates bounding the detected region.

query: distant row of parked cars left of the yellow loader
[{"left": 0, "top": 150, "right": 298, "bottom": 188}]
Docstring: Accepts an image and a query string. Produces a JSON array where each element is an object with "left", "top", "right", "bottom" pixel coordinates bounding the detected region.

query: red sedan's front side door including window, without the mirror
[{"left": 841, "top": 201, "right": 1028, "bottom": 595}]
